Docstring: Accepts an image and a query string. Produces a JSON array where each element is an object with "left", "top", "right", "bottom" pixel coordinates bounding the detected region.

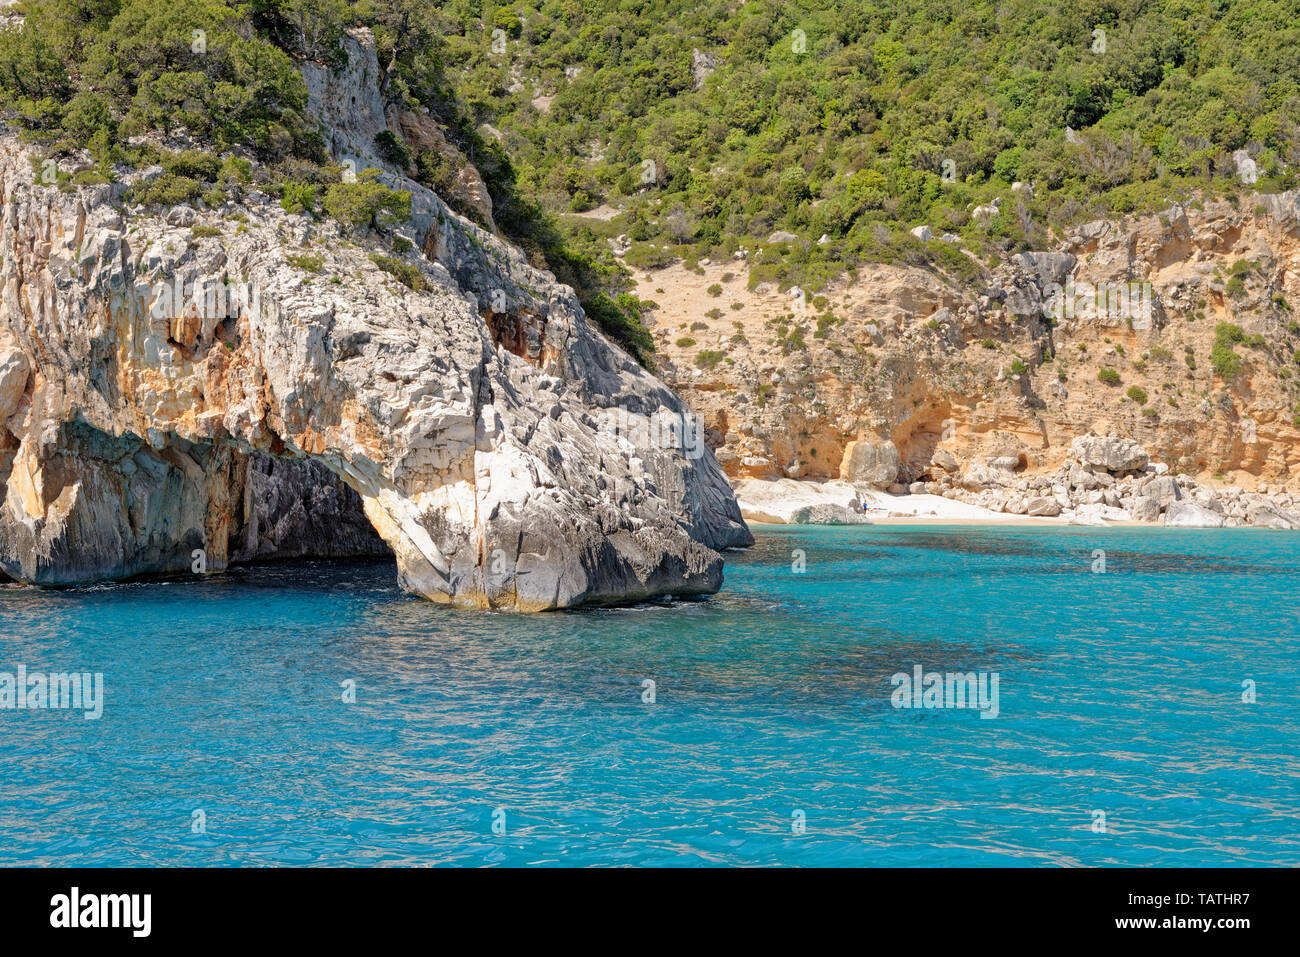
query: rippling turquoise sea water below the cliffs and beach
[{"left": 0, "top": 527, "right": 1300, "bottom": 866}]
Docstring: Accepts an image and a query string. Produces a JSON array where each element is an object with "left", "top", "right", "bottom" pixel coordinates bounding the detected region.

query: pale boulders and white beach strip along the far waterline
[{"left": 735, "top": 436, "right": 1300, "bottom": 531}]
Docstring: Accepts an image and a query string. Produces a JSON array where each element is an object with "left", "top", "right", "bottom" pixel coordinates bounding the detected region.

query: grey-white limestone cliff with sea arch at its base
[{"left": 0, "top": 37, "right": 751, "bottom": 610}]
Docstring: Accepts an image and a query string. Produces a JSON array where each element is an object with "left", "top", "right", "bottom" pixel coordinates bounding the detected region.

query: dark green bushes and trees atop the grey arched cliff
[{"left": 0, "top": 0, "right": 653, "bottom": 361}]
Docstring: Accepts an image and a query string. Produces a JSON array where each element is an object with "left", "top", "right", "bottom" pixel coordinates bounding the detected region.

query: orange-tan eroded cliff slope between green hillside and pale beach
[{"left": 636, "top": 194, "right": 1300, "bottom": 489}]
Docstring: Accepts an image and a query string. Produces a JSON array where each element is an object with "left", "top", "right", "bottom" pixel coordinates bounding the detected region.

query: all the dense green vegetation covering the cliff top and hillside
[{"left": 0, "top": 0, "right": 1300, "bottom": 358}]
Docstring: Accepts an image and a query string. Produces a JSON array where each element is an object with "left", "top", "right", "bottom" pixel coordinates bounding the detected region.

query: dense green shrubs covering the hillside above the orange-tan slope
[{"left": 421, "top": 0, "right": 1300, "bottom": 287}]
